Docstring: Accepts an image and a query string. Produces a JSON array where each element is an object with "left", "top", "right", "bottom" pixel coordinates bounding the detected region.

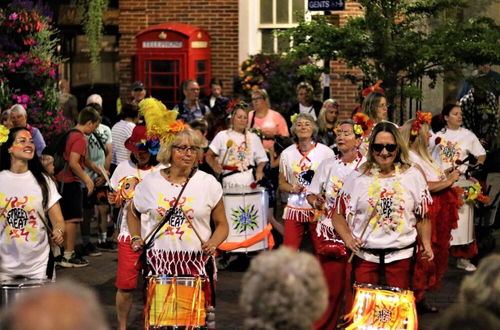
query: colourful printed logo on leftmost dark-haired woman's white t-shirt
[{"left": 0, "top": 196, "right": 39, "bottom": 244}]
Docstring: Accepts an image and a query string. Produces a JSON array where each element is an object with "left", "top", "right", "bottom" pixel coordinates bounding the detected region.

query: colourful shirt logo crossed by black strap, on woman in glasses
[{"left": 156, "top": 194, "right": 194, "bottom": 241}]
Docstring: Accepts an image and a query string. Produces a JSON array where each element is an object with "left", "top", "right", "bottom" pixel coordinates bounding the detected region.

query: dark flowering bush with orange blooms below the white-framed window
[{"left": 239, "top": 54, "right": 321, "bottom": 113}]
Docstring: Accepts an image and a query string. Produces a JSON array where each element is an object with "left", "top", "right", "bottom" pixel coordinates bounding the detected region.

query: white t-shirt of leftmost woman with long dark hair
[{"left": 0, "top": 170, "right": 61, "bottom": 279}]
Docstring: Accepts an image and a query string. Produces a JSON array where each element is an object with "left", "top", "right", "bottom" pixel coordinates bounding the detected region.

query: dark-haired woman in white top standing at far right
[{"left": 430, "top": 104, "right": 486, "bottom": 272}]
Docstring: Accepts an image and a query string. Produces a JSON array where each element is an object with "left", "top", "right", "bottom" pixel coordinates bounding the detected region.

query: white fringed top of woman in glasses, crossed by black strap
[{"left": 133, "top": 170, "right": 222, "bottom": 275}]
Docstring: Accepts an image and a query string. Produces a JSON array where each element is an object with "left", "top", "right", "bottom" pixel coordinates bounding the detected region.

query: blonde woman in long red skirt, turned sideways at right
[{"left": 401, "top": 111, "right": 460, "bottom": 312}]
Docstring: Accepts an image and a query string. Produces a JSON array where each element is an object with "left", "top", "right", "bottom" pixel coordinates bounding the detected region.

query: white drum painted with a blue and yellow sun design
[{"left": 223, "top": 186, "right": 269, "bottom": 252}]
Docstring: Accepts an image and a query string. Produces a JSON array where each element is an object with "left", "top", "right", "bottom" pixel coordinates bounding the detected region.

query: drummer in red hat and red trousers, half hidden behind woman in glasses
[{"left": 108, "top": 126, "right": 165, "bottom": 329}]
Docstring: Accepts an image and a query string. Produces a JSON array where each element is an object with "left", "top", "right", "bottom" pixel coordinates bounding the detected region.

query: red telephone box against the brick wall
[{"left": 135, "top": 23, "right": 211, "bottom": 107}]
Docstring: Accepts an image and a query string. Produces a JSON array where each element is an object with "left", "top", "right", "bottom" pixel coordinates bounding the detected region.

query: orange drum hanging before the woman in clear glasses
[{"left": 145, "top": 275, "right": 207, "bottom": 329}]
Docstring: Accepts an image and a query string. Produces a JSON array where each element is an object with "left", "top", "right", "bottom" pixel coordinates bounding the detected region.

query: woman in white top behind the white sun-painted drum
[{"left": 207, "top": 105, "right": 268, "bottom": 186}]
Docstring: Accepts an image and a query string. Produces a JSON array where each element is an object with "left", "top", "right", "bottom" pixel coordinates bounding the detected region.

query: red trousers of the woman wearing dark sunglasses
[{"left": 353, "top": 257, "right": 411, "bottom": 289}]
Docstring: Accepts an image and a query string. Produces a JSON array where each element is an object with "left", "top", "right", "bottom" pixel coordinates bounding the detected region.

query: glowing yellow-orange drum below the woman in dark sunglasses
[{"left": 345, "top": 284, "right": 418, "bottom": 330}]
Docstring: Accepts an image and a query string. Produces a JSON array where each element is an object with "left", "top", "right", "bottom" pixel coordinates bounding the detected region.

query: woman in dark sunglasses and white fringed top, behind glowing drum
[{"left": 333, "top": 122, "right": 434, "bottom": 288}]
